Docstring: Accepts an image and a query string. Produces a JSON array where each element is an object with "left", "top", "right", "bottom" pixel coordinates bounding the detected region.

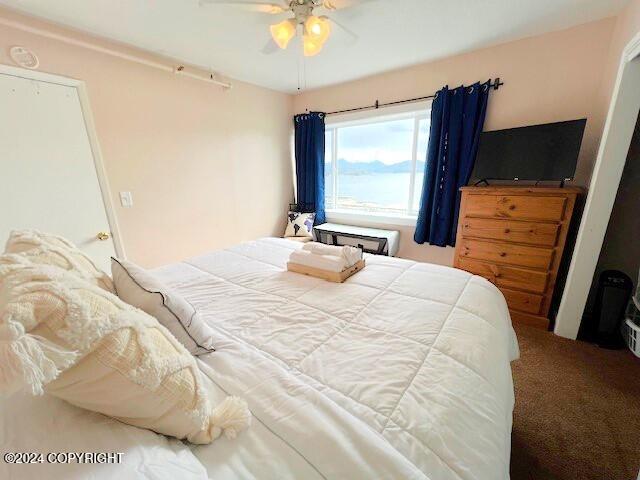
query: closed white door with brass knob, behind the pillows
[{"left": 0, "top": 68, "right": 115, "bottom": 271}]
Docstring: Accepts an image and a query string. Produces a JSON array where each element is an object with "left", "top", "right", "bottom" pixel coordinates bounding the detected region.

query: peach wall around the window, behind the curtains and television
[{"left": 294, "top": 18, "right": 616, "bottom": 265}]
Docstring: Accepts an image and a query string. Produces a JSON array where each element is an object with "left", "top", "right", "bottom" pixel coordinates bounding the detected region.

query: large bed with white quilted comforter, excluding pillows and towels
[{"left": 0, "top": 238, "right": 519, "bottom": 480}]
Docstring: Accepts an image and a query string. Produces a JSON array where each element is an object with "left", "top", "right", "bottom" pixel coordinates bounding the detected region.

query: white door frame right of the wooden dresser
[{"left": 554, "top": 32, "right": 640, "bottom": 339}]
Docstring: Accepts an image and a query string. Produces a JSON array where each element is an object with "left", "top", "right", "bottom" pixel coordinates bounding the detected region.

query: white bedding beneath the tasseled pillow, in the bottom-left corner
[{"left": 0, "top": 394, "right": 207, "bottom": 480}]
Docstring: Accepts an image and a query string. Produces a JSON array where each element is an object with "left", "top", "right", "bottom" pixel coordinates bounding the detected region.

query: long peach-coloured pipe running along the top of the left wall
[{"left": 0, "top": 17, "right": 232, "bottom": 90}]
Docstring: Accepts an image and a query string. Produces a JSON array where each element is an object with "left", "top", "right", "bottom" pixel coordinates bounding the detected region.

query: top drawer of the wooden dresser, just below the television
[{"left": 465, "top": 195, "right": 567, "bottom": 222}]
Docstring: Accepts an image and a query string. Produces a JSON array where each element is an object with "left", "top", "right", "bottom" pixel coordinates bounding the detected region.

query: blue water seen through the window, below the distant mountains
[{"left": 325, "top": 173, "right": 423, "bottom": 213}]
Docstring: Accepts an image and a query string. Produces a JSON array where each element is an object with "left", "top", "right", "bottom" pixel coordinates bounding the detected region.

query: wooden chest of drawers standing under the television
[{"left": 454, "top": 187, "right": 582, "bottom": 329}]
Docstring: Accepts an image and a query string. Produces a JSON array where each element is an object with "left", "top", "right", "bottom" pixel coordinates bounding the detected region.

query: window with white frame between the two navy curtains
[{"left": 325, "top": 104, "right": 430, "bottom": 217}]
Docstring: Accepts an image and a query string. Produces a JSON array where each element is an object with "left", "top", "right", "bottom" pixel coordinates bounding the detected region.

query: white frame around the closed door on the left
[{"left": 0, "top": 64, "right": 126, "bottom": 258}]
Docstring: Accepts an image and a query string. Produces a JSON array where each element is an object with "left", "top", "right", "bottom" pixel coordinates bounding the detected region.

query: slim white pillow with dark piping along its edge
[{"left": 111, "top": 258, "right": 215, "bottom": 355}]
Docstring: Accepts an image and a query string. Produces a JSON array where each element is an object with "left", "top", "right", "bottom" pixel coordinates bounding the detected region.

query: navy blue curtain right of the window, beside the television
[{"left": 413, "top": 82, "right": 490, "bottom": 247}]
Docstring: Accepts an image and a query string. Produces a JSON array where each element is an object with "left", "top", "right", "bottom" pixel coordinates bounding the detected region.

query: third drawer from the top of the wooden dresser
[{"left": 459, "top": 238, "right": 553, "bottom": 270}]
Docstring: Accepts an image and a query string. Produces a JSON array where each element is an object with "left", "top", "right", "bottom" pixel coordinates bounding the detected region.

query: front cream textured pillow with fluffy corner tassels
[{"left": 0, "top": 255, "right": 251, "bottom": 444}]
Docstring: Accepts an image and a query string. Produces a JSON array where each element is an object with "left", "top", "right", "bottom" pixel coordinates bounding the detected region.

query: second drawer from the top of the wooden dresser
[{"left": 462, "top": 217, "right": 560, "bottom": 247}]
